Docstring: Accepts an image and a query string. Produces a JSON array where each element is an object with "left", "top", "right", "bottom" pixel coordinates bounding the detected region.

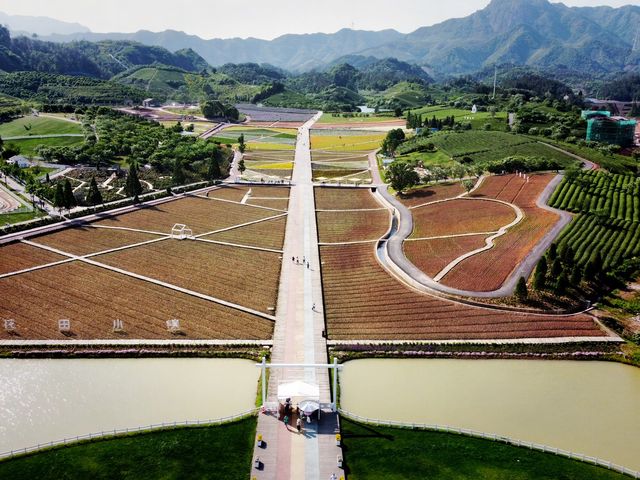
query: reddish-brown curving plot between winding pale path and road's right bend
[{"left": 441, "top": 174, "right": 559, "bottom": 292}]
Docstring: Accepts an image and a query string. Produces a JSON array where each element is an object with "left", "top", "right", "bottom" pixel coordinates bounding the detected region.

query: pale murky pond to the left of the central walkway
[{"left": 0, "top": 358, "right": 260, "bottom": 452}]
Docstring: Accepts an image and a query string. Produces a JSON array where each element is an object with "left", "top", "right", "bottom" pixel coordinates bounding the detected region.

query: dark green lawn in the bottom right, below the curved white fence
[{"left": 342, "top": 419, "right": 628, "bottom": 480}]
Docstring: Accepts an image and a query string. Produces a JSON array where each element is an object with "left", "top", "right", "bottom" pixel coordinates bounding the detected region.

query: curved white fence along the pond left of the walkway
[{"left": 0, "top": 408, "right": 258, "bottom": 459}]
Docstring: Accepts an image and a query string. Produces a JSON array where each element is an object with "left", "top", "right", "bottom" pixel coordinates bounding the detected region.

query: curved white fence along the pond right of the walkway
[{"left": 338, "top": 409, "right": 640, "bottom": 478}]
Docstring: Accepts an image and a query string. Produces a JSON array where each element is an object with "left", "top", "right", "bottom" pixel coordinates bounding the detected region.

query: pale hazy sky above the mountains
[{"left": 0, "top": 0, "right": 638, "bottom": 39}]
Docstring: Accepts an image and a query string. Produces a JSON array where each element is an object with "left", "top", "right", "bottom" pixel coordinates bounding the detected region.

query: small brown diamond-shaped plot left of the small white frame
[{"left": 31, "top": 227, "right": 161, "bottom": 255}]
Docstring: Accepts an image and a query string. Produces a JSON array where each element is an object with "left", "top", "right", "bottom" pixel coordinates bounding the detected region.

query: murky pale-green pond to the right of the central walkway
[{"left": 340, "top": 359, "right": 640, "bottom": 470}]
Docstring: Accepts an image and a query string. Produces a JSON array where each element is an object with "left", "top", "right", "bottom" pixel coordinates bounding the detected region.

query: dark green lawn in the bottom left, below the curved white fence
[{"left": 0, "top": 417, "right": 256, "bottom": 480}]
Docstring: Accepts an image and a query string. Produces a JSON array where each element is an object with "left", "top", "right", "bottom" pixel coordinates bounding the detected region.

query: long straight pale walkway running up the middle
[{"left": 251, "top": 116, "right": 344, "bottom": 480}]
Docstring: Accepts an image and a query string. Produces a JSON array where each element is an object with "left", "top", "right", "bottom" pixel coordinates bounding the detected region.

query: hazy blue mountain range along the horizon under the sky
[{"left": 8, "top": 0, "right": 640, "bottom": 76}]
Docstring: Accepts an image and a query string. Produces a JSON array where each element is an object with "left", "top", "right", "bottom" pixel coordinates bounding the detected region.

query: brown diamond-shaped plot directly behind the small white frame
[{"left": 96, "top": 197, "right": 276, "bottom": 235}]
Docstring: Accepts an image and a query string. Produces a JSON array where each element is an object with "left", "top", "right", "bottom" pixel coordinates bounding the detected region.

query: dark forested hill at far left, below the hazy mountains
[{"left": 0, "top": 26, "right": 208, "bottom": 79}]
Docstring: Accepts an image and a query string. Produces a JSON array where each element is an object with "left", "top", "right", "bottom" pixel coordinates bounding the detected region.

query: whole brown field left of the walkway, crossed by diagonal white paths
[{"left": 0, "top": 186, "right": 289, "bottom": 340}]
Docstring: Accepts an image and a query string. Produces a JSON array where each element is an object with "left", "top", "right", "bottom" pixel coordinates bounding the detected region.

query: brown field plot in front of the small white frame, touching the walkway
[{"left": 94, "top": 240, "right": 281, "bottom": 313}]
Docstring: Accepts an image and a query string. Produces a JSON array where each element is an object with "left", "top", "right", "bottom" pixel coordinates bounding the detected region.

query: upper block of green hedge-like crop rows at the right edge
[{"left": 549, "top": 170, "right": 640, "bottom": 222}]
